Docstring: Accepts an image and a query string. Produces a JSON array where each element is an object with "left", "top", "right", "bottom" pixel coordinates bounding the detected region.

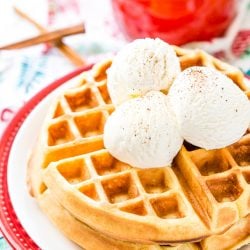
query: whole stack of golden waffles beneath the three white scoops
[{"left": 28, "top": 47, "right": 250, "bottom": 250}]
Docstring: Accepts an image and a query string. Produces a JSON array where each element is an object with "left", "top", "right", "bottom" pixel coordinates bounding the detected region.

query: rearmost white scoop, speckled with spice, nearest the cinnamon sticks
[{"left": 107, "top": 38, "right": 180, "bottom": 105}]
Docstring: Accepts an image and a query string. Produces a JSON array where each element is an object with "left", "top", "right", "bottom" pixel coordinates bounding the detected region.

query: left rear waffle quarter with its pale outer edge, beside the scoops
[{"left": 27, "top": 61, "right": 113, "bottom": 196}]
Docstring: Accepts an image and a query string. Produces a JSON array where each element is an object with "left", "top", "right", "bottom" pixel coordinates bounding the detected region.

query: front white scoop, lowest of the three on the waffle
[{"left": 104, "top": 91, "right": 183, "bottom": 168}]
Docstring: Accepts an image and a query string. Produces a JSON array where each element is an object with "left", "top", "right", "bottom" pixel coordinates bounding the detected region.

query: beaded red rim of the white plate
[{"left": 0, "top": 65, "right": 92, "bottom": 250}]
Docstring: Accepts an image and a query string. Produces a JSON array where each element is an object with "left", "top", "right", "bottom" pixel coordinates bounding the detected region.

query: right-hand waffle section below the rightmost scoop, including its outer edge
[{"left": 179, "top": 143, "right": 250, "bottom": 230}]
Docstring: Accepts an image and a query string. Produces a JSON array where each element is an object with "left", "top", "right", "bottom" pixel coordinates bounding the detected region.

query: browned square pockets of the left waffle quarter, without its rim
[{"left": 47, "top": 63, "right": 113, "bottom": 147}]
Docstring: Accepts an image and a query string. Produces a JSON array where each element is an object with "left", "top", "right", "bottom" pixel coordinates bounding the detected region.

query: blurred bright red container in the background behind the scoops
[{"left": 112, "top": 0, "right": 237, "bottom": 45}]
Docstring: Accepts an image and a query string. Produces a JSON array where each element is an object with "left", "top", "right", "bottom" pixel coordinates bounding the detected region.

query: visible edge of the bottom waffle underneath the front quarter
[{"left": 39, "top": 190, "right": 250, "bottom": 250}]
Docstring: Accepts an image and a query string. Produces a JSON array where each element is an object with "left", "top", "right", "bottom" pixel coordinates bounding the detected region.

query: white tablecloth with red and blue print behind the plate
[{"left": 0, "top": 0, "right": 250, "bottom": 250}]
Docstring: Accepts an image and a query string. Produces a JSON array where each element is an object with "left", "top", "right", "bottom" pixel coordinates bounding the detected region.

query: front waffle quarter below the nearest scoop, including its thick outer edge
[{"left": 44, "top": 149, "right": 210, "bottom": 243}]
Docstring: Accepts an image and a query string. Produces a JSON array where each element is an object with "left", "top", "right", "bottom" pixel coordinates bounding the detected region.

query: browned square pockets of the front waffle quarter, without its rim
[{"left": 53, "top": 149, "right": 191, "bottom": 218}]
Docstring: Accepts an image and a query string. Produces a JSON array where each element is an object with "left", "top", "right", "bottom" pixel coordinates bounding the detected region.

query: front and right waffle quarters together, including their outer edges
[{"left": 44, "top": 138, "right": 250, "bottom": 242}]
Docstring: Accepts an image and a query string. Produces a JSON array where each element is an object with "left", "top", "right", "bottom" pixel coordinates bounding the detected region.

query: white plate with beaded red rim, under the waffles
[{"left": 0, "top": 66, "right": 91, "bottom": 250}]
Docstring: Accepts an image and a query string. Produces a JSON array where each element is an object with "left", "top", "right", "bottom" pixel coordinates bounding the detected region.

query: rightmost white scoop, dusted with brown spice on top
[{"left": 168, "top": 66, "right": 250, "bottom": 149}]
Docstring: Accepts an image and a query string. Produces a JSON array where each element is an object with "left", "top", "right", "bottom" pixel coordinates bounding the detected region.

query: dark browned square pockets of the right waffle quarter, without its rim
[{"left": 191, "top": 146, "right": 250, "bottom": 205}]
